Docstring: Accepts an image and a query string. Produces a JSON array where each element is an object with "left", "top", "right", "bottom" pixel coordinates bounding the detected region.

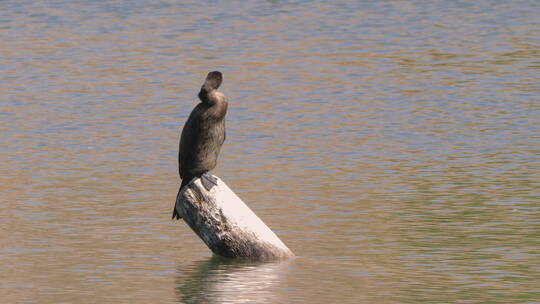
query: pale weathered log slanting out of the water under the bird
[{"left": 176, "top": 176, "right": 294, "bottom": 260}]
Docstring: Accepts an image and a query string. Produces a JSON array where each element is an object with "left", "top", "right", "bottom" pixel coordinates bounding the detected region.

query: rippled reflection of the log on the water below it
[{"left": 176, "top": 256, "right": 294, "bottom": 303}]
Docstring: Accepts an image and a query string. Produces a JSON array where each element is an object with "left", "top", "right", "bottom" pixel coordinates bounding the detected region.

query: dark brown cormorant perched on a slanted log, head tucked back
[{"left": 172, "top": 71, "right": 227, "bottom": 219}]
